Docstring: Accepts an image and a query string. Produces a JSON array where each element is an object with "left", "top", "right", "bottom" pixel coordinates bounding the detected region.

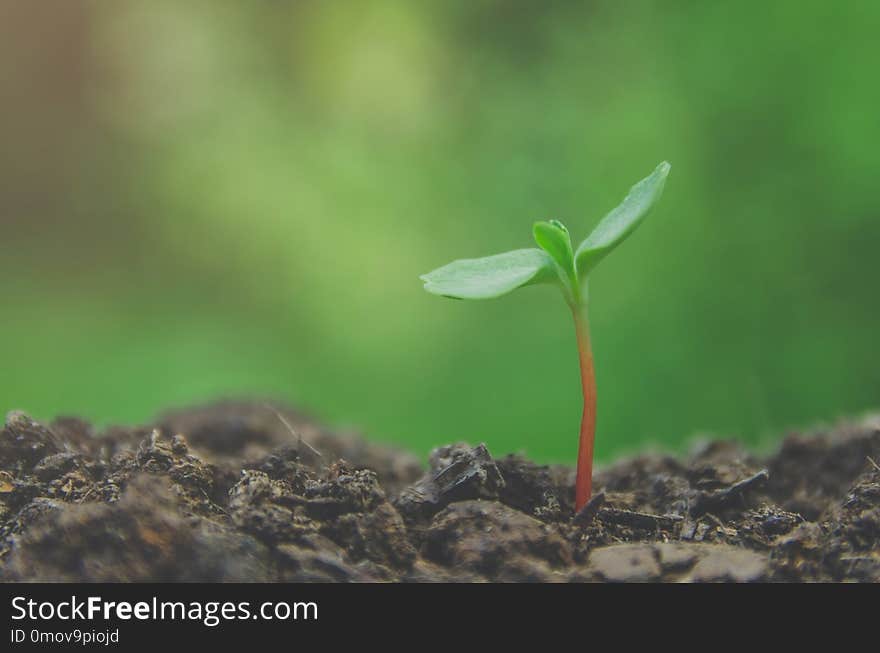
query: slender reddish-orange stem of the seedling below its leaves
[{"left": 573, "top": 306, "right": 596, "bottom": 512}]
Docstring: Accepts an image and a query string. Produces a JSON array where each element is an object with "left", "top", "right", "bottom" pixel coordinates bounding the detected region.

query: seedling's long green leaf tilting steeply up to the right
[{"left": 575, "top": 161, "right": 670, "bottom": 277}]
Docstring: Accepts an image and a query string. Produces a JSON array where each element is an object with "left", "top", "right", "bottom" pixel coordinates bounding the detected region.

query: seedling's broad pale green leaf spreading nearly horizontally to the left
[{"left": 421, "top": 249, "right": 558, "bottom": 299}]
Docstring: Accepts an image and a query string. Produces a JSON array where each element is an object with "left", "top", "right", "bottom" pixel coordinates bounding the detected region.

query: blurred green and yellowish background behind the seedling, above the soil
[{"left": 0, "top": 0, "right": 880, "bottom": 461}]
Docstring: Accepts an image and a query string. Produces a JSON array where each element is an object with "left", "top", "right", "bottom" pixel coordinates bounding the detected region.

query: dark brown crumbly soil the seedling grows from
[{"left": 0, "top": 402, "right": 880, "bottom": 582}]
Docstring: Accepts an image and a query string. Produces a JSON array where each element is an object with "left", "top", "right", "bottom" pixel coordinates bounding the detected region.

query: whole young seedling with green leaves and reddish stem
[{"left": 421, "top": 161, "right": 670, "bottom": 511}]
